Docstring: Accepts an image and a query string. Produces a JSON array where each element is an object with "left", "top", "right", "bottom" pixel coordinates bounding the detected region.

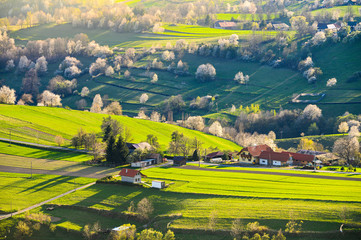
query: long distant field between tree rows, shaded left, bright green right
[{"left": 10, "top": 24, "right": 282, "bottom": 48}]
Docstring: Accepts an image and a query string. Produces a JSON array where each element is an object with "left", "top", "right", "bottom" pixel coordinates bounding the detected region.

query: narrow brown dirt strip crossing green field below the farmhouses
[{"left": 179, "top": 166, "right": 361, "bottom": 182}]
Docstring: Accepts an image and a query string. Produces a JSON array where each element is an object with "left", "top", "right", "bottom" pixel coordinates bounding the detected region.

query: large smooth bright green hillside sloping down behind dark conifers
[{"left": 0, "top": 105, "right": 241, "bottom": 150}]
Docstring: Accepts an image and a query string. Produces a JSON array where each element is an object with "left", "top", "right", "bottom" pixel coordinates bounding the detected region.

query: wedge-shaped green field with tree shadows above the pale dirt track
[{"left": 0, "top": 172, "right": 94, "bottom": 212}]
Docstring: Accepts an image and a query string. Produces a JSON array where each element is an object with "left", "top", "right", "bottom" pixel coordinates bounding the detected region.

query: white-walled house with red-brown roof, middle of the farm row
[{"left": 259, "top": 151, "right": 292, "bottom": 166}]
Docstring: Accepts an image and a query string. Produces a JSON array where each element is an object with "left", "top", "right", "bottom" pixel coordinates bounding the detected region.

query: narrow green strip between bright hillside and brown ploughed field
[{"left": 0, "top": 141, "right": 92, "bottom": 162}]
